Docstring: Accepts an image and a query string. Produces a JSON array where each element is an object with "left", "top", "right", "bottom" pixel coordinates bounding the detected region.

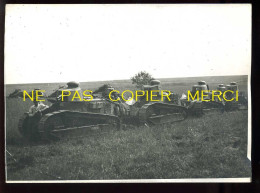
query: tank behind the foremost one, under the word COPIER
[{"left": 89, "top": 80, "right": 187, "bottom": 126}]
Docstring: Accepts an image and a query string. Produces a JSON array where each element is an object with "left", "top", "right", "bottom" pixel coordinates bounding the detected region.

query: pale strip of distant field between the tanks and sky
[{"left": 5, "top": 75, "right": 248, "bottom": 96}]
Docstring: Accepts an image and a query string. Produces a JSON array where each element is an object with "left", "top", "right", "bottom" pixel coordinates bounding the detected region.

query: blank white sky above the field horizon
[{"left": 5, "top": 4, "right": 251, "bottom": 84}]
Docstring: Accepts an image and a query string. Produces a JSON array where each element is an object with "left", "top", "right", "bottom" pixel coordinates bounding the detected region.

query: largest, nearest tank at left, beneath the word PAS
[{"left": 18, "top": 82, "right": 120, "bottom": 139}]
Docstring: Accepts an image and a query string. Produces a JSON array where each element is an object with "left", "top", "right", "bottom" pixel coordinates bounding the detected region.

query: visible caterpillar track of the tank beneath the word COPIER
[{"left": 139, "top": 103, "right": 187, "bottom": 125}]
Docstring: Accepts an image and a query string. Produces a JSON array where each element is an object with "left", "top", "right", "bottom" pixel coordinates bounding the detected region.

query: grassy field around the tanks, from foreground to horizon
[{"left": 6, "top": 76, "right": 251, "bottom": 180}]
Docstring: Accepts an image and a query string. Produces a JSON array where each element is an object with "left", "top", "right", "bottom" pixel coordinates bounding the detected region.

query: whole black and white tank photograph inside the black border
[{"left": 4, "top": 4, "right": 252, "bottom": 183}]
